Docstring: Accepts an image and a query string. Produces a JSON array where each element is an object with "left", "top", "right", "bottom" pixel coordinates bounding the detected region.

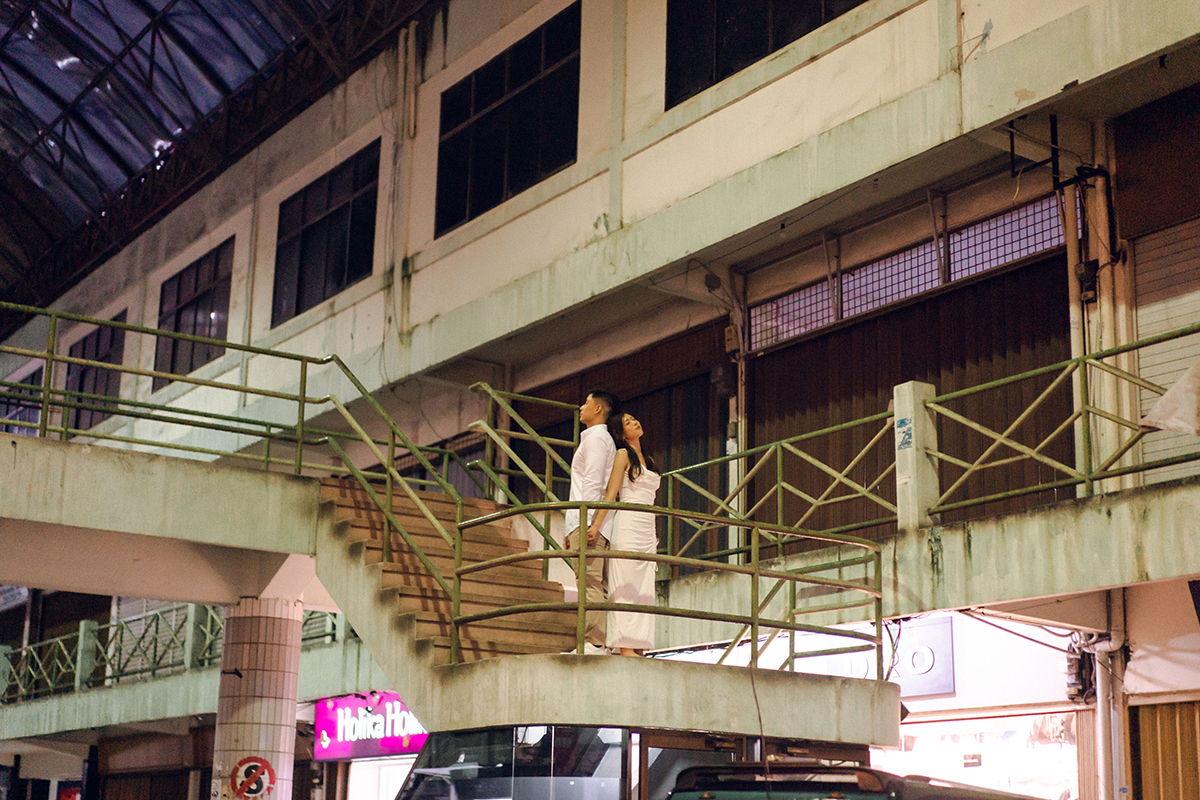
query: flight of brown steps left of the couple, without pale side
[{"left": 322, "top": 479, "right": 576, "bottom": 664}]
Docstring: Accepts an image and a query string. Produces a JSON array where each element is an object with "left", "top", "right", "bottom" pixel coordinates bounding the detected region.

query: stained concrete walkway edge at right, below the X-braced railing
[{"left": 659, "top": 479, "right": 1200, "bottom": 646}]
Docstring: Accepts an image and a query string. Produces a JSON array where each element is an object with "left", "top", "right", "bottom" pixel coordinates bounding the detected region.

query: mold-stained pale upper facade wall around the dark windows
[{"left": 4, "top": 0, "right": 1200, "bottom": 441}]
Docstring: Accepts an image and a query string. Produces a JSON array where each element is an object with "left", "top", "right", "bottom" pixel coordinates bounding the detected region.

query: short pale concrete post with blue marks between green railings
[{"left": 892, "top": 380, "right": 941, "bottom": 531}]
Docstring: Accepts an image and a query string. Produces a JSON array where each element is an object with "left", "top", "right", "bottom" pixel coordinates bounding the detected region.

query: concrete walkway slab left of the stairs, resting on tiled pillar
[{"left": 0, "top": 434, "right": 329, "bottom": 599}]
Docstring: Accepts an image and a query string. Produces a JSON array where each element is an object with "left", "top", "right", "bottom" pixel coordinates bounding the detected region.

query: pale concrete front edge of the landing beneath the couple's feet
[{"left": 426, "top": 655, "right": 900, "bottom": 746}]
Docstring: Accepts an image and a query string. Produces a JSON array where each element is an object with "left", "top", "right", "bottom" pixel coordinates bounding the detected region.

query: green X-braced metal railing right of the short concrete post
[{"left": 925, "top": 324, "right": 1200, "bottom": 513}]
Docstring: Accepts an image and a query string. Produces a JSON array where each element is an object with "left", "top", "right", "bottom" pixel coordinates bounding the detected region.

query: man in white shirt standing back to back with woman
[{"left": 566, "top": 389, "right": 620, "bottom": 652}]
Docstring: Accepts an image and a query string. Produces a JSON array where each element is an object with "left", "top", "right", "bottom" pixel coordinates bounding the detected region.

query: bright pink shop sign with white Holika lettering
[{"left": 313, "top": 692, "right": 428, "bottom": 760}]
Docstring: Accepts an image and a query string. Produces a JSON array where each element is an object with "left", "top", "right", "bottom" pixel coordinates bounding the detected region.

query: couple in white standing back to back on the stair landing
[{"left": 566, "top": 389, "right": 659, "bottom": 656}]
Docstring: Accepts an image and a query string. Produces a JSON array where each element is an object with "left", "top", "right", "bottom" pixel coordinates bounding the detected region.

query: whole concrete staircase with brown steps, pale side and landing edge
[{"left": 313, "top": 480, "right": 900, "bottom": 746}]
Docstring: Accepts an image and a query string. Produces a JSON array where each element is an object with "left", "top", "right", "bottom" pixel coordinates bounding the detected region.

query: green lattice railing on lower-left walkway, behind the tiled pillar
[{"left": 0, "top": 603, "right": 336, "bottom": 703}]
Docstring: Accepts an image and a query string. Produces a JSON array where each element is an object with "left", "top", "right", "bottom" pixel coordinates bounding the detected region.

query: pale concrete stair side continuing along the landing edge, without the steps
[{"left": 317, "top": 503, "right": 900, "bottom": 746}]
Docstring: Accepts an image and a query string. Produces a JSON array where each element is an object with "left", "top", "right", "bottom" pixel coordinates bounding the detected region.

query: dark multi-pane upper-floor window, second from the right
[{"left": 434, "top": 2, "right": 580, "bottom": 236}]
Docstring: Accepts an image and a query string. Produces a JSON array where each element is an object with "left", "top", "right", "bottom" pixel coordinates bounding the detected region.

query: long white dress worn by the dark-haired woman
[{"left": 607, "top": 469, "right": 660, "bottom": 650}]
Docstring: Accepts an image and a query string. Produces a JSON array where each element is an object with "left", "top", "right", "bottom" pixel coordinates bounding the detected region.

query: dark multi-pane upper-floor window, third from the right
[{"left": 271, "top": 139, "right": 379, "bottom": 327}]
